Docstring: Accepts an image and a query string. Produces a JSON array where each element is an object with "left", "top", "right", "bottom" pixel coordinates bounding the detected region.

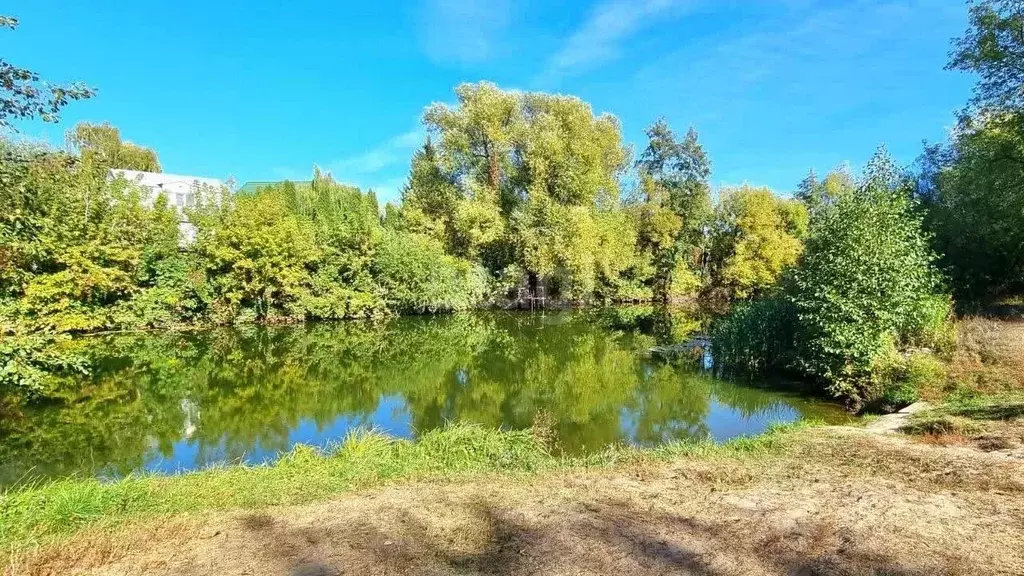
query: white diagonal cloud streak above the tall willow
[{"left": 539, "top": 0, "right": 693, "bottom": 82}]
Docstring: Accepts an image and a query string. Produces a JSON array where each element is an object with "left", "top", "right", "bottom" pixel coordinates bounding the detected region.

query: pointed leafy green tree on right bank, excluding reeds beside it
[{"left": 790, "top": 151, "right": 938, "bottom": 401}]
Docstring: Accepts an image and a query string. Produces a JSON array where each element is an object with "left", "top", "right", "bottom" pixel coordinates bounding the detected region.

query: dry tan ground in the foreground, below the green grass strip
[{"left": 14, "top": 428, "right": 1024, "bottom": 576}]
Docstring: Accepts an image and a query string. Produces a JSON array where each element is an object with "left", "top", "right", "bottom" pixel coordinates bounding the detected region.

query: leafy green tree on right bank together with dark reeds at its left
[{"left": 715, "top": 150, "right": 952, "bottom": 404}]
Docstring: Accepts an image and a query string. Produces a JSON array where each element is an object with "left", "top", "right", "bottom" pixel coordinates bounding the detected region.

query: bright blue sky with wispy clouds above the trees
[{"left": 0, "top": 0, "right": 972, "bottom": 199}]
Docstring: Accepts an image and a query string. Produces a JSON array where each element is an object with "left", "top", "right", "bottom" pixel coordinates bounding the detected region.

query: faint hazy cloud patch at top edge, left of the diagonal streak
[{"left": 420, "top": 0, "right": 512, "bottom": 65}]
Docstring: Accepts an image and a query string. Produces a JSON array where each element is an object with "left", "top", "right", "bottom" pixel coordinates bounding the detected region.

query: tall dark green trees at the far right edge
[{"left": 918, "top": 0, "right": 1024, "bottom": 306}]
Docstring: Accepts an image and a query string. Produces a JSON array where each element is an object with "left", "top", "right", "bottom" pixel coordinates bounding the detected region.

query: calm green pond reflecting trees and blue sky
[{"left": 0, "top": 308, "right": 848, "bottom": 485}]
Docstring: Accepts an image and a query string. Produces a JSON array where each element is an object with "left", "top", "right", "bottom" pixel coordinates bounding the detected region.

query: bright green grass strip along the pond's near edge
[{"left": 0, "top": 424, "right": 806, "bottom": 552}]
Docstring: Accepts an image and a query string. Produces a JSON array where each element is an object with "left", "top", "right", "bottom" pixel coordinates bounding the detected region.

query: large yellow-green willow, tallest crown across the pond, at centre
[{"left": 403, "top": 83, "right": 635, "bottom": 299}]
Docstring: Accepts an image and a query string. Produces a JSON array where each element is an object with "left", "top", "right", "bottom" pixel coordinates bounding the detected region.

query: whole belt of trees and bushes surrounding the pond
[{"left": 0, "top": 0, "right": 1024, "bottom": 403}]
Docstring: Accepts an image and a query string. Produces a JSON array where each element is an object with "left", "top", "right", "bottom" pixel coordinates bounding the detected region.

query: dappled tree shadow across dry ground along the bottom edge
[{"left": 235, "top": 494, "right": 962, "bottom": 576}]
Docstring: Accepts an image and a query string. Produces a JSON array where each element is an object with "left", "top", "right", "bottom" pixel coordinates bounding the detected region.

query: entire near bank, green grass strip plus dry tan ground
[{"left": 0, "top": 404, "right": 1024, "bottom": 575}]
